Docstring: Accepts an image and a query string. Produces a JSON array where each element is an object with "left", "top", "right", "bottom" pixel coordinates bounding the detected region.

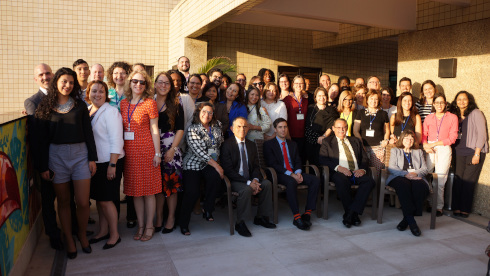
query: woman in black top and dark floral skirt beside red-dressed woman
[{"left": 155, "top": 72, "right": 184, "bottom": 234}]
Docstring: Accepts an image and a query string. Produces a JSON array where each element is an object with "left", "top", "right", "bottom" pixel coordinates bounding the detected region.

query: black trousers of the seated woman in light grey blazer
[{"left": 388, "top": 176, "right": 429, "bottom": 217}]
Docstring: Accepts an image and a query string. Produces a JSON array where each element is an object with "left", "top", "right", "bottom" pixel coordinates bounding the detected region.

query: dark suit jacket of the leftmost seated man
[{"left": 220, "top": 136, "right": 262, "bottom": 183}]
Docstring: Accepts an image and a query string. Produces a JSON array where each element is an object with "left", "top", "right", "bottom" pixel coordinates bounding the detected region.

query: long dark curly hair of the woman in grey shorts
[{"left": 35, "top": 67, "right": 81, "bottom": 120}]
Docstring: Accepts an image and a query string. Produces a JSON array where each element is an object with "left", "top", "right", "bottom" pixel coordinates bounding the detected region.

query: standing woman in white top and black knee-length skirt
[{"left": 87, "top": 81, "right": 124, "bottom": 249}]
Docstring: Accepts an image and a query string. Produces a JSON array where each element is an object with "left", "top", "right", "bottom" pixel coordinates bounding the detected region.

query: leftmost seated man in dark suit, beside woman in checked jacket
[{"left": 220, "top": 117, "right": 276, "bottom": 237}]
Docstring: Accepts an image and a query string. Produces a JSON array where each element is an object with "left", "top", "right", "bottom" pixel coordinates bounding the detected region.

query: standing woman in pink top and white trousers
[{"left": 422, "top": 92, "right": 458, "bottom": 217}]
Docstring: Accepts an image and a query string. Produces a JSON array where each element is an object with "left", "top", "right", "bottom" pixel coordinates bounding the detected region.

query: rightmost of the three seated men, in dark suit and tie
[{"left": 319, "top": 119, "right": 375, "bottom": 228}]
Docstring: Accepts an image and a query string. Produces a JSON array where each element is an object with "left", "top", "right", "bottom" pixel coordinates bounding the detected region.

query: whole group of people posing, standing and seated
[{"left": 25, "top": 56, "right": 488, "bottom": 258}]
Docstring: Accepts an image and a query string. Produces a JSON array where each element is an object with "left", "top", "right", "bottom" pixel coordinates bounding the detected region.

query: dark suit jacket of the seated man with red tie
[{"left": 264, "top": 138, "right": 301, "bottom": 173}]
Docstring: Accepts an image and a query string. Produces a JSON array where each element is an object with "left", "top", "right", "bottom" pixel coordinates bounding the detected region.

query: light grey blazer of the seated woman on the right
[{"left": 386, "top": 148, "right": 428, "bottom": 185}]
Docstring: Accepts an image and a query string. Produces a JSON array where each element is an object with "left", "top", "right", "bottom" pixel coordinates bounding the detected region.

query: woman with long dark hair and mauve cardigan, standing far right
[{"left": 451, "top": 91, "right": 488, "bottom": 218}]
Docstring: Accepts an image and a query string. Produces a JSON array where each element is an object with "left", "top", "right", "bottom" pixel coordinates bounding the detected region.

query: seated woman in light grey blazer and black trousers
[{"left": 386, "top": 130, "right": 429, "bottom": 236}]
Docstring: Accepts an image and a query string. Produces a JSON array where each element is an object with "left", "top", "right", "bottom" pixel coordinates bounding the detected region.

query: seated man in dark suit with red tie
[{"left": 264, "top": 118, "right": 320, "bottom": 230}]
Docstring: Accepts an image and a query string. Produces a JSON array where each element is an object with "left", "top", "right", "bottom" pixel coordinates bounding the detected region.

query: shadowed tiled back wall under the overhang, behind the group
[{"left": 198, "top": 23, "right": 397, "bottom": 89}]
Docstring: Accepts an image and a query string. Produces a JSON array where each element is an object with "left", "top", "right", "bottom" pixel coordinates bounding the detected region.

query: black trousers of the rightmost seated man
[{"left": 330, "top": 172, "right": 376, "bottom": 215}]
